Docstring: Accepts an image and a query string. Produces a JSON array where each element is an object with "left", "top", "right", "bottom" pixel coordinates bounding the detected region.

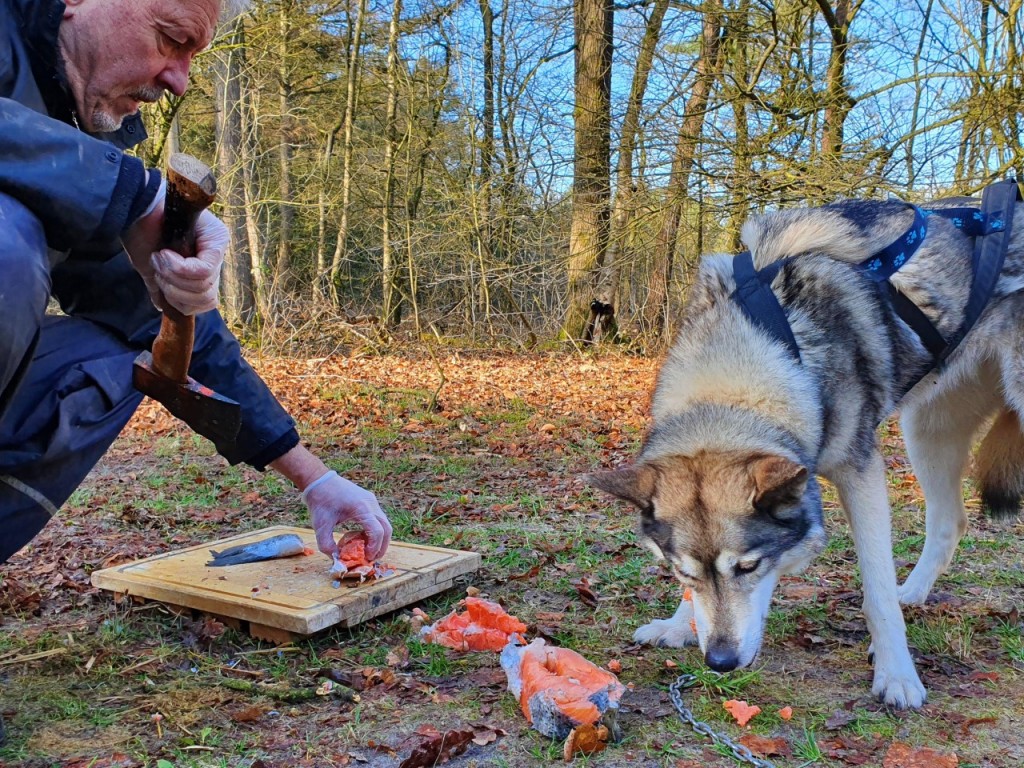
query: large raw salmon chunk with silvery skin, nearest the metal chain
[{"left": 502, "top": 638, "right": 626, "bottom": 738}]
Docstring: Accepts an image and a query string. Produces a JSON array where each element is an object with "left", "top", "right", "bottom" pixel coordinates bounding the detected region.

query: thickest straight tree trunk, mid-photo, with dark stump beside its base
[{"left": 562, "top": 0, "right": 614, "bottom": 339}]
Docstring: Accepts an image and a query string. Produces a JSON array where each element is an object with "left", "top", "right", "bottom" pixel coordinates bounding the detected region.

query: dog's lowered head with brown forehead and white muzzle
[{"left": 589, "top": 452, "right": 825, "bottom": 672}]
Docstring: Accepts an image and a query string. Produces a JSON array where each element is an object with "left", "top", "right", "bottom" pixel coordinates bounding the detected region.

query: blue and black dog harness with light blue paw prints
[{"left": 731, "top": 178, "right": 1022, "bottom": 378}]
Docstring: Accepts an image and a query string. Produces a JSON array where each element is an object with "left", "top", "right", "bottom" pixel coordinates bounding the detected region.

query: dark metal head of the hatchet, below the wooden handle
[{"left": 132, "top": 351, "right": 242, "bottom": 445}]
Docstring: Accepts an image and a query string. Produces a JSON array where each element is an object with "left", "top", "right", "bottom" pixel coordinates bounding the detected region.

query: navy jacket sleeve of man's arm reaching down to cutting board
[{"left": 52, "top": 252, "right": 299, "bottom": 470}]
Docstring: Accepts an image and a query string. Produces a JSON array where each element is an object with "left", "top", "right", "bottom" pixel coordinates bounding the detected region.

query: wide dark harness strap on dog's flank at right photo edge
[{"left": 936, "top": 178, "right": 1022, "bottom": 366}]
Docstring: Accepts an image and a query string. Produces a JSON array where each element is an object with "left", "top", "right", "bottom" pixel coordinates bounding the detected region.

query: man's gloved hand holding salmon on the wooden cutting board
[{"left": 302, "top": 470, "right": 391, "bottom": 560}]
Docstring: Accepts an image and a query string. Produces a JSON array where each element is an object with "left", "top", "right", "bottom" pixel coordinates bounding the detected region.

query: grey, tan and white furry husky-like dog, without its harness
[{"left": 591, "top": 199, "right": 1024, "bottom": 708}]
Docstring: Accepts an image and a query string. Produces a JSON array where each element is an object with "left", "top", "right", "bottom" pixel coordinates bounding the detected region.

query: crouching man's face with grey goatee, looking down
[{"left": 58, "top": 0, "right": 220, "bottom": 131}]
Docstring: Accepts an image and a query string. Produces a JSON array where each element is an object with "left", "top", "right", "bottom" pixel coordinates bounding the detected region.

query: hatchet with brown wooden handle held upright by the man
[{"left": 132, "top": 153, "right": 242, "bottom": 444}]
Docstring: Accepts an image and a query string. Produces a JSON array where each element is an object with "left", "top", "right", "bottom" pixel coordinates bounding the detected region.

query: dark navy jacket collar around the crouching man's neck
[{"left": 9, "top": 0, "right": 146, "bottom": 150}]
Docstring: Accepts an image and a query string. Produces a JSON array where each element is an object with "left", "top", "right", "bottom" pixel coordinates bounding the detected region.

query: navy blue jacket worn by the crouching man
[{"left": 0, "top": 0, "right": 299, "bottom": 469}]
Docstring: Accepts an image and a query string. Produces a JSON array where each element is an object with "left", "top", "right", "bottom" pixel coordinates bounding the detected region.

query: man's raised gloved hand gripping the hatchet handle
[{"left": 121, "top": 180, "right": 230, "bottom": 314}]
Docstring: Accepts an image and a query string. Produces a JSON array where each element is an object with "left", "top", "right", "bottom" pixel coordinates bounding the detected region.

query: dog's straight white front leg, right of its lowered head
[{"left": 830, "top": 452, "right": 926, "bottom": 709}]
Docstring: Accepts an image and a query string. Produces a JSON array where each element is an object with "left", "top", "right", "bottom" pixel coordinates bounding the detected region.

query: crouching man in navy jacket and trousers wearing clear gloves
[{"left": 0, "top": 0, "right": 391, "bottom": 606}]
